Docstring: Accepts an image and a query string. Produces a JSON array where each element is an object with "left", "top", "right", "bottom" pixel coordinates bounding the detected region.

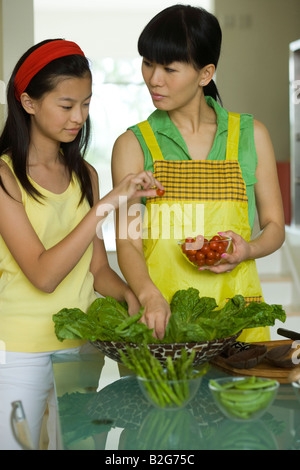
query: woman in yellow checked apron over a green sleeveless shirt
[{"left": 112, "top": 5, "right": 284, "bottom": 340}]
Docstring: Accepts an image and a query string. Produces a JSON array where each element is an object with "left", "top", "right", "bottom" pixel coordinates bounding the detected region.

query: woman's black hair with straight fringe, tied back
[{"left": 138, "top": 4, "right": 222, "bottom": 104}]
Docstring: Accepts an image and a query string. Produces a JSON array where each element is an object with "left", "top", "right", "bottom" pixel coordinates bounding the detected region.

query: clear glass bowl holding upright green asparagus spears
[{"left": 137, "top": 376, "right": 202, "bottom": 410}]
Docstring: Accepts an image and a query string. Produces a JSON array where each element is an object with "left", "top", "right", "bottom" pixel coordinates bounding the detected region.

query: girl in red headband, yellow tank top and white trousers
[{"left": 0, "top": 39, "right": 162, "bottom": 449}]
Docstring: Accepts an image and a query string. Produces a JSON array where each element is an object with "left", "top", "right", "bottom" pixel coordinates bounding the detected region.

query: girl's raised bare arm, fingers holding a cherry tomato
[{"left": 0, "top": 158, "right": 161, "bottom": 293}]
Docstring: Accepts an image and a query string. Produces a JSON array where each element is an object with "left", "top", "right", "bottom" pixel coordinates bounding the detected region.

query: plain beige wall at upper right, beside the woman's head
[{"left": 215, "top": 0, "right": 300, "bottom": 161}]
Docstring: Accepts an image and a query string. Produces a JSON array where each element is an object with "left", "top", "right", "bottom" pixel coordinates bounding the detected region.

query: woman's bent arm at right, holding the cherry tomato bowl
[{"left": 210, "top": 120, "right": 285, "bottom": 272}]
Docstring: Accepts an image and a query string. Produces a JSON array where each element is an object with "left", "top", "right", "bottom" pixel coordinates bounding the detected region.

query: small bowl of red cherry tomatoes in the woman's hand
[{"left": 178, "top": 235, "right": 232, "bottom": 268}]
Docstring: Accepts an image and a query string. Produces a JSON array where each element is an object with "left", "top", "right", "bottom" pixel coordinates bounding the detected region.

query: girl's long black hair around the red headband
[{"left": 0, "top": 39, "right": 93, "bottom": 206}]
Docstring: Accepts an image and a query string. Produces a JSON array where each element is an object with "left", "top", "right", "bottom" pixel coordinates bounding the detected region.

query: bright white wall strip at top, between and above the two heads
[{"left": 34, "top": 0, "right": 213, "bottom": 59}]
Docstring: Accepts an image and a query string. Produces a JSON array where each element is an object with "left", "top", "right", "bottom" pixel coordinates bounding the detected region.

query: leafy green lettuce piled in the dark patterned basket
[{"left": 53, "top": 288, "right": 286, "bottom": 343}]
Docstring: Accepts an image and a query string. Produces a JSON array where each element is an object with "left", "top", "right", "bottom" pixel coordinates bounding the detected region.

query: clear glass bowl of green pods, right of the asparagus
[{"left": 209, "top": 377, "right": 279, "bottom": 422}]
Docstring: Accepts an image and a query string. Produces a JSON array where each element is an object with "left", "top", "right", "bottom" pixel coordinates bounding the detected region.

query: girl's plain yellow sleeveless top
[{"left": 0, "top": 155, "right": 96, "bottom": 352}]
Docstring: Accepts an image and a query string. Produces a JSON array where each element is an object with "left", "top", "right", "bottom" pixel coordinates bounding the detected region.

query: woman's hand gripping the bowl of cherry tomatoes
[{"left": 199, "top": 231, "right": 251, "bottom": 274}]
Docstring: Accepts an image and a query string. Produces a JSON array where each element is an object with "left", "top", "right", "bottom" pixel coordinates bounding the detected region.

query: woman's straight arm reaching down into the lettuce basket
[{"left": 112, "top": 131, "right": 170, "bottom": 338}]
